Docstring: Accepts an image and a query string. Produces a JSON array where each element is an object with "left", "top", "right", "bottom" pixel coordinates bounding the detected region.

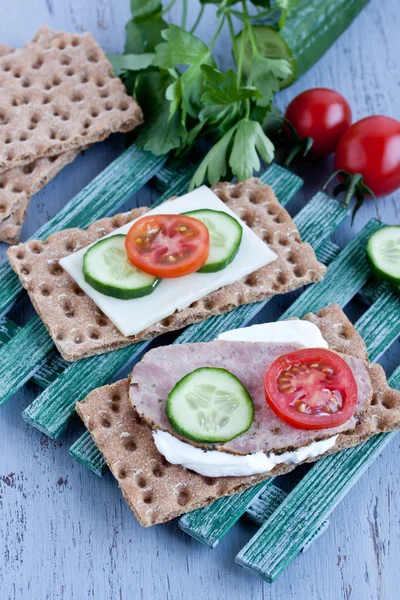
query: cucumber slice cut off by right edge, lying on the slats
[{"left": 367, "top": 225, "right": 400, "bottom": 286}]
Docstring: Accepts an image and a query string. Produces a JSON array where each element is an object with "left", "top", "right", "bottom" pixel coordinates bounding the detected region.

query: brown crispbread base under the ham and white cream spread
[{"left": 76, "top": 305, "right": 400, "bottom": 527}]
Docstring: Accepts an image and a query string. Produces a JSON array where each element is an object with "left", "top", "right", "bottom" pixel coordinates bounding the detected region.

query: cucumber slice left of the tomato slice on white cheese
[{"left": 83, "top": 234, "right": 160, "bottom": 300}]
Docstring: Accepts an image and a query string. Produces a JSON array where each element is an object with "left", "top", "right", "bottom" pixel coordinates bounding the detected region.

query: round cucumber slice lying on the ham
[{"left": 166, "top": 367, "right": 254, "bottom": 444}]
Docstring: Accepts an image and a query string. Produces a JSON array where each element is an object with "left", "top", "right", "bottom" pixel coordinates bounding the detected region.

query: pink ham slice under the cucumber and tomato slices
[{"left": 130, "top": 341, "right": 372, "bottom": 454}]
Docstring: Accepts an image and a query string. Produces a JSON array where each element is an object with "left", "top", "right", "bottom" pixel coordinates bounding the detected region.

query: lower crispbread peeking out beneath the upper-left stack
[{"left": 0, "top": 151, "right": 76, "bottom": 244}]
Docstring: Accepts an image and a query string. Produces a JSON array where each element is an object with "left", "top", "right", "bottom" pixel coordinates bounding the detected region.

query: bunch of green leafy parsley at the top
[{"left": 109, "top": 0, "right": 294, "bottom": 188}]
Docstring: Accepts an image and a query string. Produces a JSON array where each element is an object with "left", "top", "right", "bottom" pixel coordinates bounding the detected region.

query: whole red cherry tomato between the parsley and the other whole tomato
[{"left": 285, "top": 88, "right": 351, "bottom": 158}]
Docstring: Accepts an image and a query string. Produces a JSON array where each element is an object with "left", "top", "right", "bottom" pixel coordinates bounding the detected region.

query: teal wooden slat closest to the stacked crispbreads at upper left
[{"left": 0, "top": 146, "right": 166, "bottom": 315}]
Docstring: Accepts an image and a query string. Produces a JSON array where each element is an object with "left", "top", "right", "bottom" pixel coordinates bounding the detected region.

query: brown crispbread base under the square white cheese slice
[{"left": 8, "top": 179, "right": 325, "bottom": 361}]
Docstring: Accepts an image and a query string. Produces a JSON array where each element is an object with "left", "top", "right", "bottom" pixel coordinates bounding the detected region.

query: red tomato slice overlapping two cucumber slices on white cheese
[{"left": 125, "top": 215, "right": 210, "bottom": 279}]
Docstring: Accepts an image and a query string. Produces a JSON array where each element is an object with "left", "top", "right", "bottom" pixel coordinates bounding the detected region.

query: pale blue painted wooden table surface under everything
[{"left": 0, "top": 0, "right": 400, "bottom": 600}]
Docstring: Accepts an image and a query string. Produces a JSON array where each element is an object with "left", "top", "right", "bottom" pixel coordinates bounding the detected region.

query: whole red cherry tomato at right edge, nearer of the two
[{"left": 335, "top": 115, "right": 400, "bottom": 196}]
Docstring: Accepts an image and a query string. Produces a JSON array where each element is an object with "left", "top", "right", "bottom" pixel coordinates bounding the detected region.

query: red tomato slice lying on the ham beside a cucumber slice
[{"left": 264, "top": 348, "right": 358, "bottom": 429}]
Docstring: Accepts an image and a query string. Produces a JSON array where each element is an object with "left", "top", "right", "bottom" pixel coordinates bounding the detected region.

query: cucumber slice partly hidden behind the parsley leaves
[{"left": 236, "top": 25, "right": 296, "bottom": 89}]
